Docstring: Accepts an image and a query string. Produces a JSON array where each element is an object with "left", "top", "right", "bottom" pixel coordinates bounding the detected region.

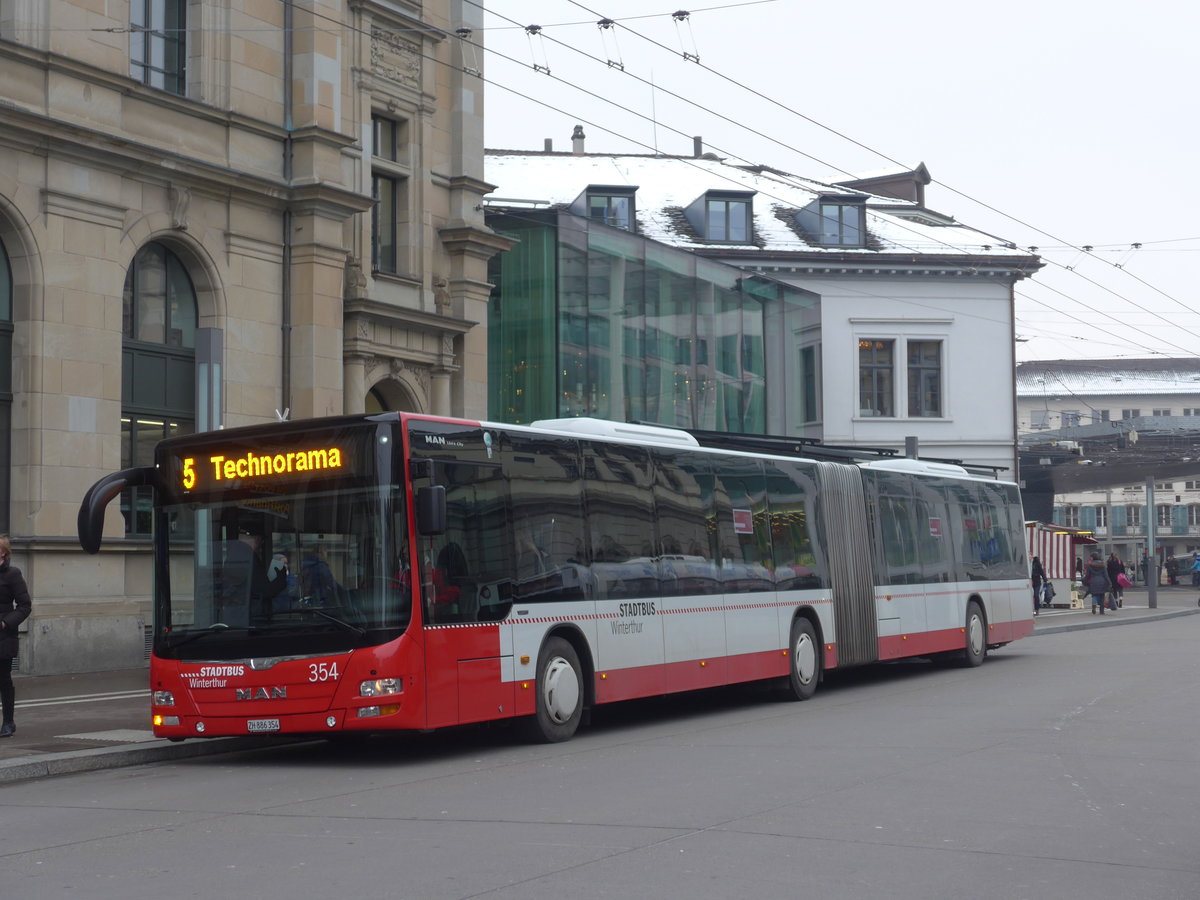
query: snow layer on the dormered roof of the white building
[{"left": 484, "top": 150, "right": 1030, "bottom": 258}]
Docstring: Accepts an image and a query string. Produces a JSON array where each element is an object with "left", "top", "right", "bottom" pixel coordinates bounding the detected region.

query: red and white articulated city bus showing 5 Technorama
[{"left": 79, "top": 413, "right": 1032, "bottom": 740}]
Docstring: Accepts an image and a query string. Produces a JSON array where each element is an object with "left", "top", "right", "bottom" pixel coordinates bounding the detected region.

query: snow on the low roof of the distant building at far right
[{"left": 1016, "top": 358, "right": 1200, "bottom": 397}]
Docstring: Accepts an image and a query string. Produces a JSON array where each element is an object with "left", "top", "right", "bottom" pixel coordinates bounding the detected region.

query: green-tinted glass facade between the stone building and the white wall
[{"left": 488, "top": 210, "right": 816, "bottom": 433}]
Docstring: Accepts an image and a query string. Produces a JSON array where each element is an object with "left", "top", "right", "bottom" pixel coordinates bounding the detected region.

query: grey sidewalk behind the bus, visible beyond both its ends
[{"left": 0, "top": 586, "right": 1200, "bottom": 785}]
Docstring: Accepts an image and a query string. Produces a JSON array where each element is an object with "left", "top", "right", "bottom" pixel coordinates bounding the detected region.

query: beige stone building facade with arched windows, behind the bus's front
[{"left": 0, "top": 0, "right": 509, "bottom": 673}]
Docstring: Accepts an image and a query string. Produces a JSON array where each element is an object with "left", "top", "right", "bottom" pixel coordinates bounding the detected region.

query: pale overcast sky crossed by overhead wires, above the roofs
[{"left": 482, "top": 0, "right": 1200, "bottom": 361}]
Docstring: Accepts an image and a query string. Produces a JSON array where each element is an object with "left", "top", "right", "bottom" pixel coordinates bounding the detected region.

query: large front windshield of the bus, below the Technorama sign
[{"left": 154, "top": 488, "right": 410, "bottom": 660}]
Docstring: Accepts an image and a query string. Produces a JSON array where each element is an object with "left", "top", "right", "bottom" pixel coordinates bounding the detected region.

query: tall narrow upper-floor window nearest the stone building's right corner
[{"left": 371, "top": 115, "right": 409, "bottom": 275}]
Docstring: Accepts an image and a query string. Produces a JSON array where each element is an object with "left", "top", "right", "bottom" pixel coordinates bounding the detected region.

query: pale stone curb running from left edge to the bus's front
[{"left": 0, "top": 737, "right": 312, "bottom": 785}]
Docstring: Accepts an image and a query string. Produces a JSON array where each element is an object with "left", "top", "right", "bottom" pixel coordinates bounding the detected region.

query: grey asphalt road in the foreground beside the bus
[{"left": 0, "top": 616, "right": 1200, "bottom": 900}]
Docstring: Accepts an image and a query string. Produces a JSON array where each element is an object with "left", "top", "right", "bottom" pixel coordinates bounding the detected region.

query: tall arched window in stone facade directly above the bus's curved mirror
[{"left": 121, "top": 242, "right": 197, "bottom": 538}]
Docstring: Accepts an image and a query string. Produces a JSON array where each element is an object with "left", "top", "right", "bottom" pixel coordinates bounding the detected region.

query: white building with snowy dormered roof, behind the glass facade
[{"left": 485, "top": 138, "right": 1042, "bottom": 478}]
